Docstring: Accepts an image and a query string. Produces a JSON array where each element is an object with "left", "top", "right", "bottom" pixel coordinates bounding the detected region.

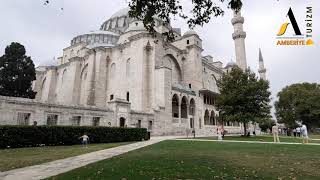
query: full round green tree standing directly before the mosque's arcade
[{"left": 217, "top": 67, "right": 271, "bottom": 135}]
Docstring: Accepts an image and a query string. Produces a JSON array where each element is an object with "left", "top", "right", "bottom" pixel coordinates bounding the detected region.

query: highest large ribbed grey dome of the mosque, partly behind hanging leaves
[{"left": 100, "top": 8, "right": 131, "bottom": 34}]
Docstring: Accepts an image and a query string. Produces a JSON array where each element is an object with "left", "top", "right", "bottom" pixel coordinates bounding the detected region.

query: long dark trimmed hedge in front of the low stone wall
[{"left": 0, "top": 126, "right": 149, "bottom": 148}]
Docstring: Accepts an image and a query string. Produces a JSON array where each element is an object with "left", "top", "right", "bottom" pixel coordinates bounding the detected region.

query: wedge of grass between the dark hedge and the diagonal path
[{"left": 0, "top": 142, "right": 129, "bottom": 171}]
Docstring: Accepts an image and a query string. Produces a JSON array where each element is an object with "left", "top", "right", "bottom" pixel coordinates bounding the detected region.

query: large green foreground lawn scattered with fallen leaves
[{"left": 51, "top": 140, "right": 320, "bottom": 180}]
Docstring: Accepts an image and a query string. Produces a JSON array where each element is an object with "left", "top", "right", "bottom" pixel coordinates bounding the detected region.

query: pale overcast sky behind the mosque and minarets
[{"left": 0, "top": 0, "right": 320, "bottom": 116}]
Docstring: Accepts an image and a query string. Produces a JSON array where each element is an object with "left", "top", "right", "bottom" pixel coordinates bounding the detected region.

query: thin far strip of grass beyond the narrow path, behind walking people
[{"left": 197, "top": 135, "right": 320, "bottom": 143}]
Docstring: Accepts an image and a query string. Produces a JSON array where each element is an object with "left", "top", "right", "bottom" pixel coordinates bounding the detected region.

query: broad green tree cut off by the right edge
[{"left": 275, "top": 83, "right": 320, "bottom": 131}]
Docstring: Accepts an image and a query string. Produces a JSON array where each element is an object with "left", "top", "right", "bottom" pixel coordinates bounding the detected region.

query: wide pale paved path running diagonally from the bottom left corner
[{"left": 0, "top": 136, "right": 181, "bottom": 180}]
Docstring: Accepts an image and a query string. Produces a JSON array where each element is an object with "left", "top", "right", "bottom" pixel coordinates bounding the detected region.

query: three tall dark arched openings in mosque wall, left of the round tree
[{"left": 172, "top": 94, "right": 195, "bottom": 118}]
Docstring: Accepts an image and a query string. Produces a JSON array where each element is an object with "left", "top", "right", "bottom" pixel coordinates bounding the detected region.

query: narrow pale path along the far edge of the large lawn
[{"left": 174, "top": 139, "right": 320, "bottom": 146}]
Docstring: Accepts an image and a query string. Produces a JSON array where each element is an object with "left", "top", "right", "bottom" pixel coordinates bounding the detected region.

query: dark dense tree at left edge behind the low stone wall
[{"left": 0, "top": 42, "right": 36, "bottom": 99}]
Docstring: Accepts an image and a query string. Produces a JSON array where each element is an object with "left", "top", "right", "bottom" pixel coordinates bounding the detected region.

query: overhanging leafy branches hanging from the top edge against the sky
[{"left": 129, "top": 0, "right": 242, "bottom": 40}]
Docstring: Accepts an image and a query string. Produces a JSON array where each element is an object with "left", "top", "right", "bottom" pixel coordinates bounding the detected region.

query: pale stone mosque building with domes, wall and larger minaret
[{"left": 0, "top": 9, "right": 264, "bottom": 135}]
